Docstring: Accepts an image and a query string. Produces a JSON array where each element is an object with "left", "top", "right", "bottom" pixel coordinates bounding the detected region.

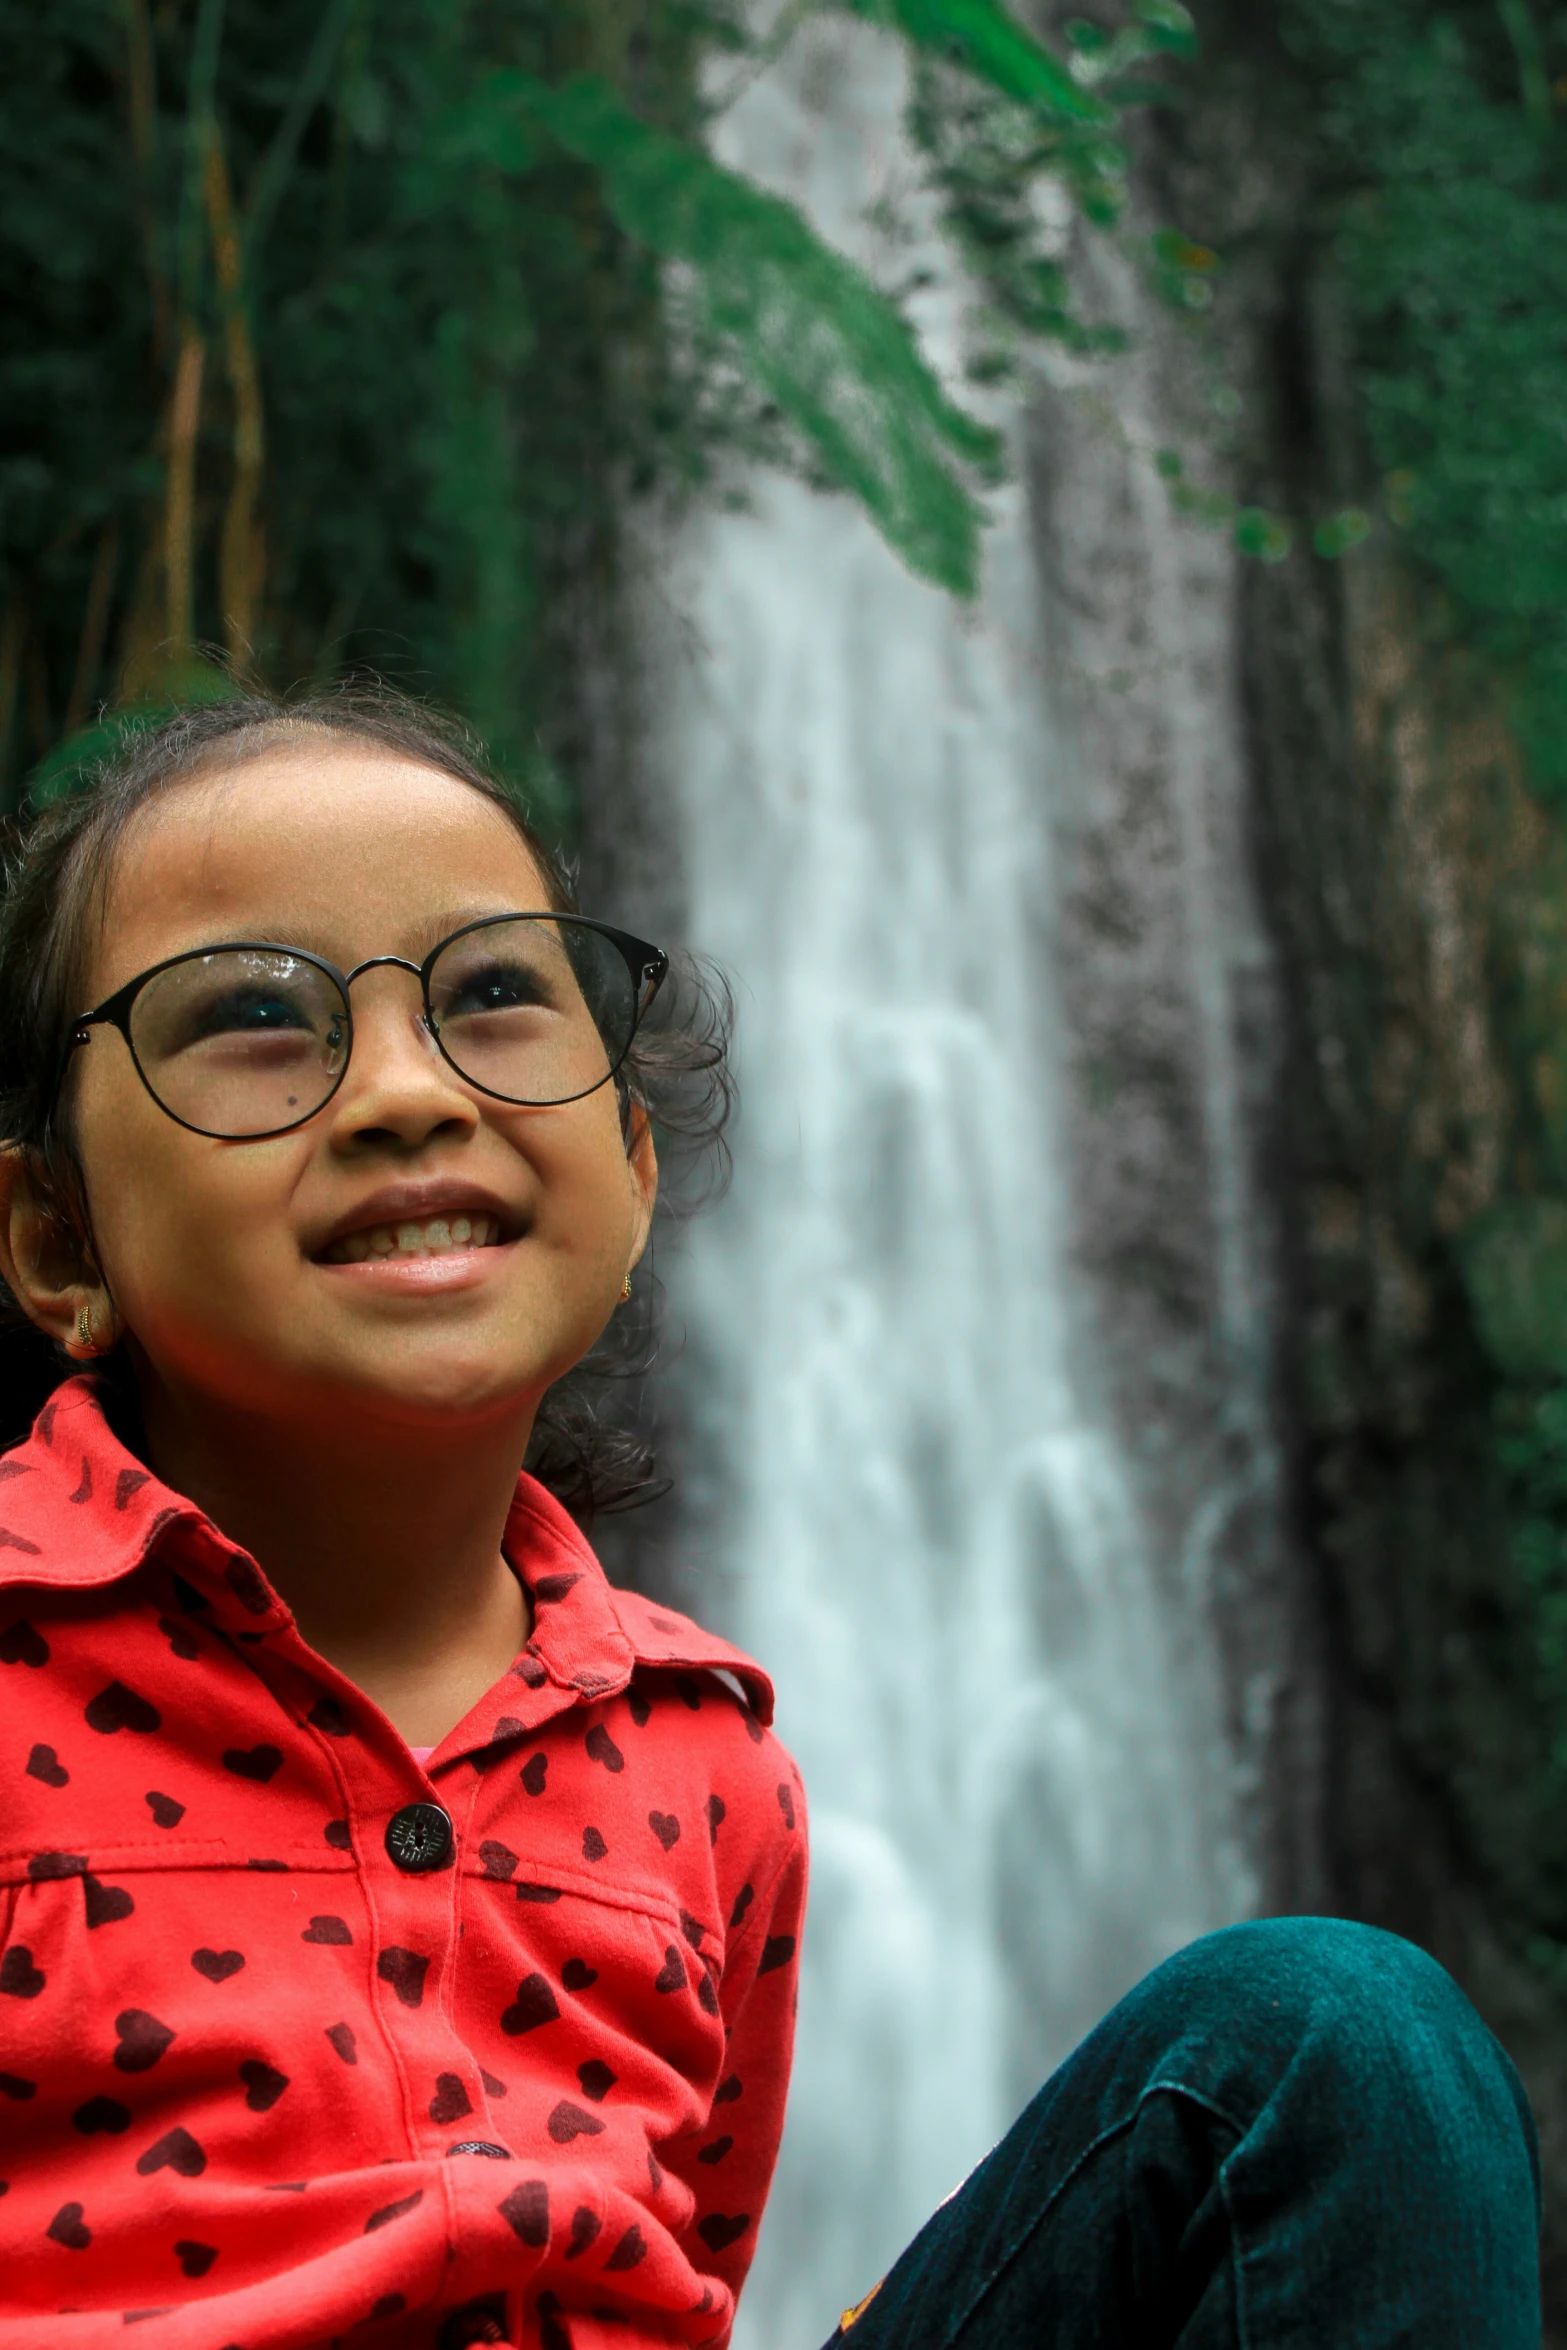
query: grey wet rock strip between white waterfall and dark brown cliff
[{"left": 1027, "top": 244, "right": 1323, "bottom": 1945}]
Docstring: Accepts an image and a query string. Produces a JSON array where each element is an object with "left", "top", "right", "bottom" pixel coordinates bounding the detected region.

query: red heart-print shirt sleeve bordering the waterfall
[{"left": 667, "top": 1781, "right": 806, "bottom": 2345}]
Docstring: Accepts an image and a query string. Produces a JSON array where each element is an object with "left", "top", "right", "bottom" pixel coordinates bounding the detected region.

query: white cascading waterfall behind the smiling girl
[{"left": 620, "top": 21, "right": 1306, "bottom": 2350}]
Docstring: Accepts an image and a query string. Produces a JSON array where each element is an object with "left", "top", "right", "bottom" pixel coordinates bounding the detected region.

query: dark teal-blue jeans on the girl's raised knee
[{"left": 834, "top": 1918, "right": 1541, "bottom": 2350}]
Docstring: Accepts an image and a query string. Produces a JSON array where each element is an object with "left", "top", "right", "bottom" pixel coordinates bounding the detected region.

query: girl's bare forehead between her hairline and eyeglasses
[{"left": 89, "top": 740, "right": 550, "bottom": 1001}]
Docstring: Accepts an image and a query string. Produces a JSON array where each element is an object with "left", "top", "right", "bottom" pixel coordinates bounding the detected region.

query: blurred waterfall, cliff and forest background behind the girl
[{"left": 0, "top": 0, "right": 1567, "bottom": 2350}]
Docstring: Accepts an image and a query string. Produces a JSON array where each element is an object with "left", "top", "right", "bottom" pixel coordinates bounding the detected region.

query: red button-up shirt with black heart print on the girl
[{"left": 0, "top": 1379, "right": 806, "bottom": 2350}]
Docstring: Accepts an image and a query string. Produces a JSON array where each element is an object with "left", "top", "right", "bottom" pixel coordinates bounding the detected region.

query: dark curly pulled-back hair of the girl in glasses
[{"left": 0, "top": 684, "right": 733, "bottom": 1523}]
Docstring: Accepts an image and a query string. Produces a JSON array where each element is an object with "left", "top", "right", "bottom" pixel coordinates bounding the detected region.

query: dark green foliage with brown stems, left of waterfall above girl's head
[{"left": 0, "top": 0, "right": 695, "bottom": 836}]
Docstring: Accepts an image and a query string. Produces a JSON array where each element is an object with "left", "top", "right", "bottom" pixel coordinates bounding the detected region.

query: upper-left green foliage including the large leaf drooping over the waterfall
[{"left": 0, "top": 0, "right": 1151, "bottom": 825}]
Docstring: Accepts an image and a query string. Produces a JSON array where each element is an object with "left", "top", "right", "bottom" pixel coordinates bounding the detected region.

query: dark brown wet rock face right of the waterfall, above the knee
[{"left": 1245, "top": 524, "right": 1567, "bottom": 2303}]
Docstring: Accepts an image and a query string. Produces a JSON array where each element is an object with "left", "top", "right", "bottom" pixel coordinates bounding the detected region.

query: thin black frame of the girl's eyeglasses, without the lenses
[{"left": 61, "top": 912, "right": 670, "bottom": 1142}]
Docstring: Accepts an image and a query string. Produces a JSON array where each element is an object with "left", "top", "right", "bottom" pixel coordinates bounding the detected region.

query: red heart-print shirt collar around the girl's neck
[{"left": 0, "top": 1372, "right": 773, "bottom": 1755}]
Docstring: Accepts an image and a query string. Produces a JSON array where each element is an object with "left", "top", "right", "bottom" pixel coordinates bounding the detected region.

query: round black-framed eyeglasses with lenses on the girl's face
[{"left": 70, "top": 914, "right": 670, "bottom": 1142}]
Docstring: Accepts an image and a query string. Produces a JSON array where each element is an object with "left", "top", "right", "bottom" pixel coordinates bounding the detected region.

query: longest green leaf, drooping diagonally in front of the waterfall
[{"left": 470, "top": 71, "right": 1001, "bottom": 595}]
